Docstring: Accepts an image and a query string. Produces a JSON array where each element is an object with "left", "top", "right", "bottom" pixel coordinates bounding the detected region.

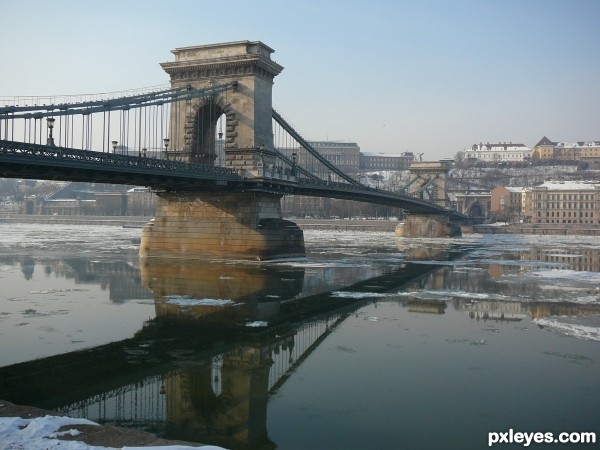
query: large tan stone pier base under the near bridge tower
[{"left": 140, "top": 193, "right": 305, "bottom": 260}]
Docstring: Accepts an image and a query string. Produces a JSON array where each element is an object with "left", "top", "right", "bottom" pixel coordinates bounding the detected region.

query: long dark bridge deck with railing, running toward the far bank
[{"left": 0, "top": 140, "right": 461, "bottom": 219}]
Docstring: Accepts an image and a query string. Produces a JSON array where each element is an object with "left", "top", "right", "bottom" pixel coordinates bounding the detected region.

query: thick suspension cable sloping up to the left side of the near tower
[{"left": 0, "top": 81, "right": 238, "bottom": 120}]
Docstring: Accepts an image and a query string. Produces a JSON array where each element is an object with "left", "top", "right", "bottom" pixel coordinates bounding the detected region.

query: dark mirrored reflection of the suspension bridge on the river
[{"left": 0, "top": 263, "right": 435, "bottom": 448}]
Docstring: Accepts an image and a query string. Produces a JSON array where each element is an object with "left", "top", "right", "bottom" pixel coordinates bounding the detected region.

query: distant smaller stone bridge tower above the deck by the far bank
[{"left": 407, "top": 160, "right": 452, "bottom": 207}]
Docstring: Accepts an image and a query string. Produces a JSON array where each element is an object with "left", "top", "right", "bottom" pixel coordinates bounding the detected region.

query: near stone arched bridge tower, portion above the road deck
[{"left": 161, "top": 41, "right": 283, "bottom": 175}]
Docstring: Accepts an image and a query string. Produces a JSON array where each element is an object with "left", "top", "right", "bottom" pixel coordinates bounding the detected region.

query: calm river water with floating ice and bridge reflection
[{"left": 0, "top": 224, "right": 600, "bottom": 450}]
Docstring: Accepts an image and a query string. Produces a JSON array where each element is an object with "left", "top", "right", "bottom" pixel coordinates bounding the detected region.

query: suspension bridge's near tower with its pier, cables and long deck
[{"left": 0, "top": 41, "right": 458, "bottom": 259}]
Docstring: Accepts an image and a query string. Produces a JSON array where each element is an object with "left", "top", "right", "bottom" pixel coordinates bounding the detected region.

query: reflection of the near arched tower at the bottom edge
[{"left": 164, "top": 345, "right": 275, "bottom": 450}]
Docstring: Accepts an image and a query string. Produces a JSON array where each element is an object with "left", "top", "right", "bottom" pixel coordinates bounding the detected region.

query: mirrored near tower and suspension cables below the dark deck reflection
[{"left": 55, "top": 314, "right": 345, "bottom": 449}]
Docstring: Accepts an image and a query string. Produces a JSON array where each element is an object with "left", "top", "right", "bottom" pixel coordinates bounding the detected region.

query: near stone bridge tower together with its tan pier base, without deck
[{"left": 140, "top": 41, "right": 304, "bottom": 260}]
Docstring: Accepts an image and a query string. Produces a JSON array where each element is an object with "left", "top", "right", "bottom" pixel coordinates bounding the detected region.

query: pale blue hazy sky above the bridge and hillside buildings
[{"left": 0, "top": 0, "right": 600, "bottom": 160}]
